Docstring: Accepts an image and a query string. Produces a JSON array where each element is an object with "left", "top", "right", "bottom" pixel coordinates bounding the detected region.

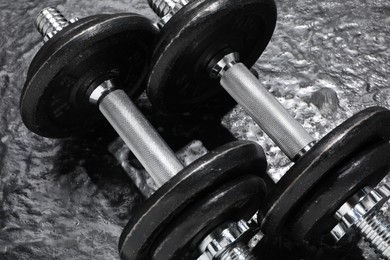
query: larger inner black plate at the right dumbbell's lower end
[{"left": 259, "top": 107, "right": 390, "bottom": 235}]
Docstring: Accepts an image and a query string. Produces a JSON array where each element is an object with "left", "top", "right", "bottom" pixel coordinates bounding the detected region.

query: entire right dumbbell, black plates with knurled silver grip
[{"left": 142, "top": 0, "right": 390, "bottom": 257}]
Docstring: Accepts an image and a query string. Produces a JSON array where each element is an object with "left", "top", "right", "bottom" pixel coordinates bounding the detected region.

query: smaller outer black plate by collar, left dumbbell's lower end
[{"left": 151, "top": 175, "right": 266, "bottom": 260}]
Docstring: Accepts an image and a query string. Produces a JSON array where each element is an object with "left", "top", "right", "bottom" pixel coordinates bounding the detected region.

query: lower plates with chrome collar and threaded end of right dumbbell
[{"left": 258, "top": 107, "right": 390, "bottom": 259}]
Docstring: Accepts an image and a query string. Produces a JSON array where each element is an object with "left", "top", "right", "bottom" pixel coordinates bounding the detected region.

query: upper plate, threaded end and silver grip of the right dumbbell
[{"left": 147, "top": 0, "right": 314, "bottom": 160}]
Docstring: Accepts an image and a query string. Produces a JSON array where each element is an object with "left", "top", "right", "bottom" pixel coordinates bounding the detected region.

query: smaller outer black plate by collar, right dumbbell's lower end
[{"left": 289, "top": 142, "right": 390, "bottom": 242}]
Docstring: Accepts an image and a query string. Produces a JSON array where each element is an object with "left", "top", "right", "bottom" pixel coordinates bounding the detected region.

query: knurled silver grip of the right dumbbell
[{"left": 221, "top": 63, "right": 314, "bottom": 160}]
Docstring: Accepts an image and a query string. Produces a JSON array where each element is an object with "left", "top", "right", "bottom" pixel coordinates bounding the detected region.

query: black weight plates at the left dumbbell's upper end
[{"left": 20, "top": 13, "right": 157, "bottom": 137}]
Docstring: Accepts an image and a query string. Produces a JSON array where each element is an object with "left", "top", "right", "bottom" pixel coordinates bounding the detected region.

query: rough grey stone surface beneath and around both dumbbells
[{"left": 0, "top": 0, "right": 390, "bottom": 260}]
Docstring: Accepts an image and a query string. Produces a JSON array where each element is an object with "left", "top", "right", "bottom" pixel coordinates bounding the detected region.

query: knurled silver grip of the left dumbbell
[{"left": 99, "top": 90, "right": 183, "bottom": 187}]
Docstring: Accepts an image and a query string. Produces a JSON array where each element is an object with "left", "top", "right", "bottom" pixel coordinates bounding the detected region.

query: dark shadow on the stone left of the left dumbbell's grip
[{"left": 54, "top": 125, "right": 144, "bottom": 217}]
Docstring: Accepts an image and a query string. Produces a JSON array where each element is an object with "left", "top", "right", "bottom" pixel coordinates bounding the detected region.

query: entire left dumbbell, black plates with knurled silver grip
[{"left": 20, "top": 8, "right": 267, "bottom": 259}]
